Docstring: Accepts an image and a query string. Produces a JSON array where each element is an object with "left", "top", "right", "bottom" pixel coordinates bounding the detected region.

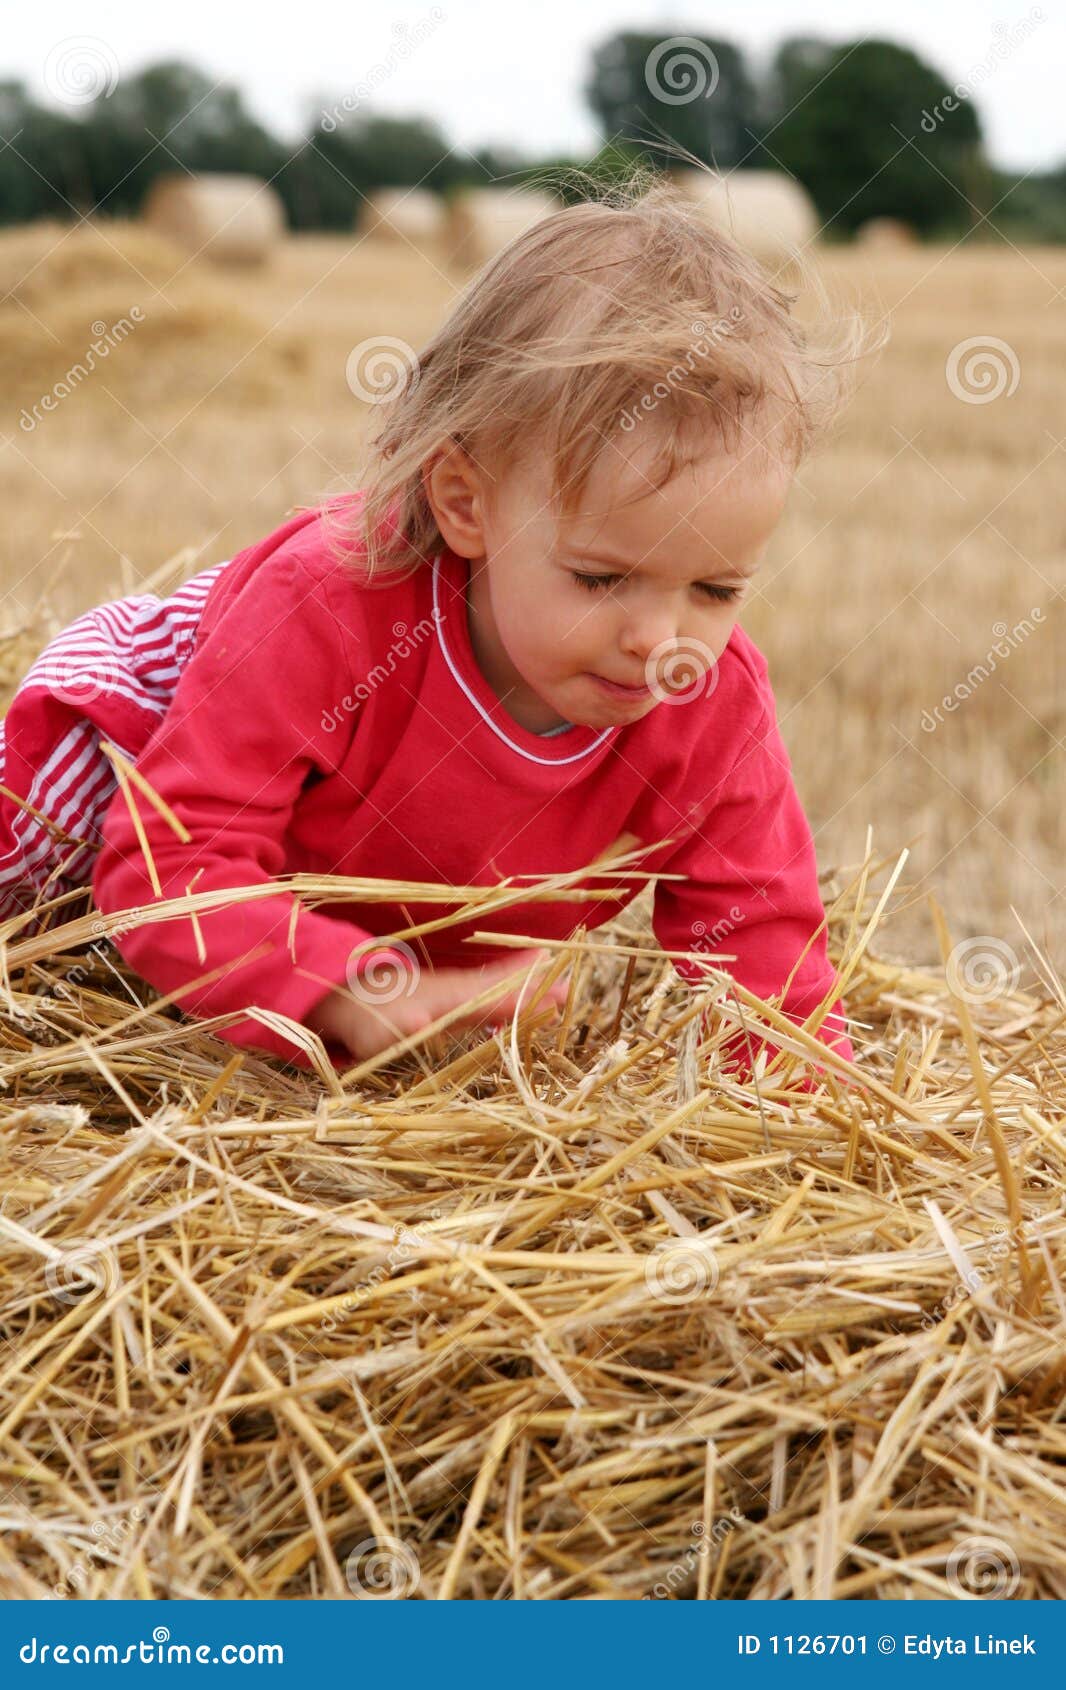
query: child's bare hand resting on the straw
[{"left": 307, "top": 950, "right": 569, "bottom": 1061}]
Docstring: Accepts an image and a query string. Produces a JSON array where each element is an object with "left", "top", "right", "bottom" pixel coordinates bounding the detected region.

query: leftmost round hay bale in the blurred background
[{"left": 142, "top": 174, "right": 286, "bottom": 264}]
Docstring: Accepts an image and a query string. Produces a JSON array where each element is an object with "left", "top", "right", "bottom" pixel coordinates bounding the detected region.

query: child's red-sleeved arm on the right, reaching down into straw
[{"left": 654, "top": 703, "right": 855, "bottom": 1077}]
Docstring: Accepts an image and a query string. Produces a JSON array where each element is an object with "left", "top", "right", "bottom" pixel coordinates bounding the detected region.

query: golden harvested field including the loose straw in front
[{"left": 0, "top": 226, "right": 1066, "bottom": 1600}]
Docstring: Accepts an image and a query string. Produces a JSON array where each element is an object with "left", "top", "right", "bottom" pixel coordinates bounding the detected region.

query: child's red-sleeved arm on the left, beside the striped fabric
[{"left": 93, "top": 549, "right": 398, "bottom": 1061}]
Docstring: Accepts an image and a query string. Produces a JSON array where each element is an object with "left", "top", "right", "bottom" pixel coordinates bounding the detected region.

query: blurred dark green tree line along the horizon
[{"left": 0, "top": 25, "right": 1066, "bottom": 240}]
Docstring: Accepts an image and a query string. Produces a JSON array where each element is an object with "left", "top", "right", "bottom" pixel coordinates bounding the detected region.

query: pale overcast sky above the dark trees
[{"left": 10, "top": 0, "right": 1066, "bottom": 169}]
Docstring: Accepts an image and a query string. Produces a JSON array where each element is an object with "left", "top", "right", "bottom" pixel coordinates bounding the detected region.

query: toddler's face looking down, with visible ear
[{"left": 427, "top": 425, "right": 792, "bottom": 732}]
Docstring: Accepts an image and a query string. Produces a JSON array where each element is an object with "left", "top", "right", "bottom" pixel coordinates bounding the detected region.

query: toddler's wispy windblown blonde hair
[{"left": 326, "top": 166, "right": 867, "bottom": 585}]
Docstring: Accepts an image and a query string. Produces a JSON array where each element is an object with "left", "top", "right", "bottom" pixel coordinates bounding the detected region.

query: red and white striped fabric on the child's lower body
[{"left": 0, "top": 558, "right": 231, "bottom": 919}]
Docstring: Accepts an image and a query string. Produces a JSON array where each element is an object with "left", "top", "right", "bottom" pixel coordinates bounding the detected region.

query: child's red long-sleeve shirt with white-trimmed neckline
[{"left": 93, "top": 495, "right": 853, "bottom": 1071}]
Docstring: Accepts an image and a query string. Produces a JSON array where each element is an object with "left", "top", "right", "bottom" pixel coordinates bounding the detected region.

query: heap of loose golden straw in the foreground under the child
[{"left": 0, "top": 831, "right": 1066, "bottom": 1600}]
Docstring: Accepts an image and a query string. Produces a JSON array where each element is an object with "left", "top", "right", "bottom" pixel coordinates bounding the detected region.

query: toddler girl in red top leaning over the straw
[{"left": 0, "top": 184, "right": 853, "bottom": 1073}]
